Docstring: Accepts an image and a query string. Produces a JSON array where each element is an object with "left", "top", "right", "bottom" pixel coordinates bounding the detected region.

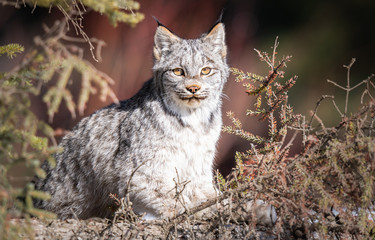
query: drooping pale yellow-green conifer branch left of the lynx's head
[{"left": 32, "top": 30, "right": 118, "bottom": 121}]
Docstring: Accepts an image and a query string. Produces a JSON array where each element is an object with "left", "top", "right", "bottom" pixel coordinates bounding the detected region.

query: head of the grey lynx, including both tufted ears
[{"left": 153, "top": 22, "right": 229, "bottom": 115}]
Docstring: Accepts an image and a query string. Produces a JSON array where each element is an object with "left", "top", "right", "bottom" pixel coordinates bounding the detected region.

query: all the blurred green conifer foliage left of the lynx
[{"left": 0, "top": 0, "right": 143, "bottom": 239}]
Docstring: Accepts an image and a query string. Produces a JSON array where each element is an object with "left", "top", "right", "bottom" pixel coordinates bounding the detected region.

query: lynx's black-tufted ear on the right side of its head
[{"left": 202, "top": 22, "right": 227, "bottom": 57}]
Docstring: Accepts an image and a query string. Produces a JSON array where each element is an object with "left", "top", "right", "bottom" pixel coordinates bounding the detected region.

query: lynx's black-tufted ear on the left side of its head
[{"left": 154, "top": 21, "right": 181, "bottom": 60}]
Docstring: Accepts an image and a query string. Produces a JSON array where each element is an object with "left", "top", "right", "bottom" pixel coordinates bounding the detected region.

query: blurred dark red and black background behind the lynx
[{"left": 0, "top": 0, "right": 375, "bottom": 174}]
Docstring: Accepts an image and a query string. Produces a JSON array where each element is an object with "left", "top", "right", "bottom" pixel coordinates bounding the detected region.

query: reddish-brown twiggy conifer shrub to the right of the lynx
[{"left": 223, "top": 40, "right": 375, "bottom": 239}]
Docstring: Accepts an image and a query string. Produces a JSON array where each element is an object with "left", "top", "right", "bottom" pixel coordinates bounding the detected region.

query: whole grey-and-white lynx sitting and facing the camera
[{"left": 35, "top": 23, "right": 229, "bottom": 219}]
